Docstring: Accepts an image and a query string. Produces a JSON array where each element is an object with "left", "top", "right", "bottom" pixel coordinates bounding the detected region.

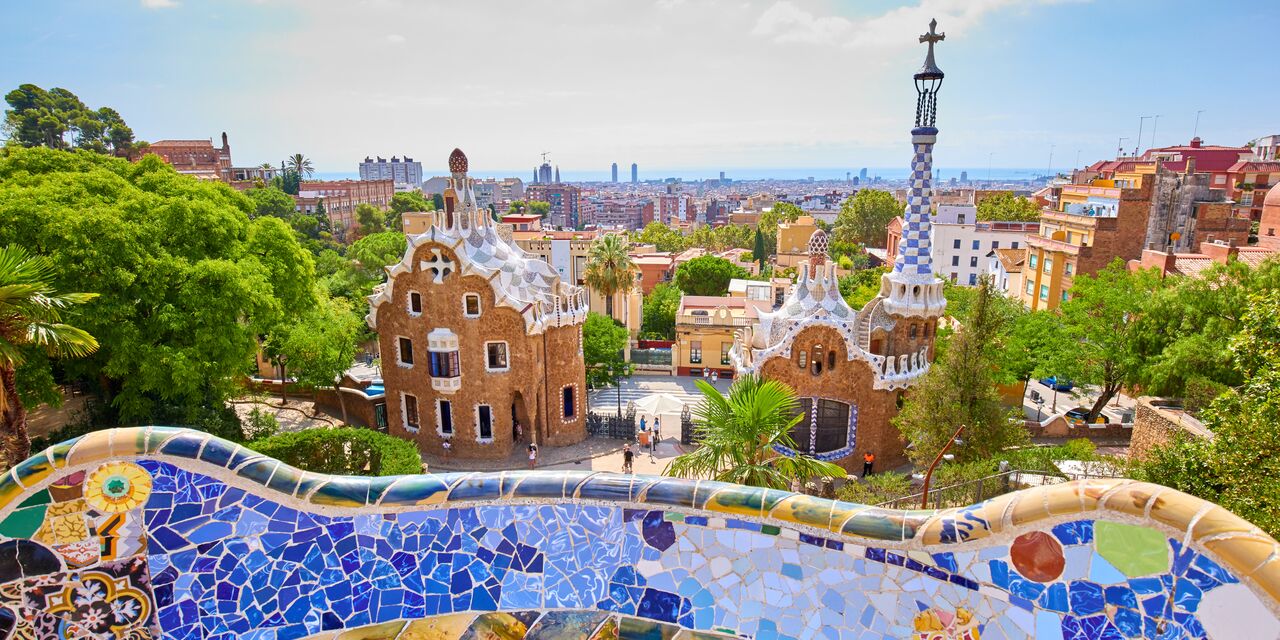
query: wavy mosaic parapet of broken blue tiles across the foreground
[{"left": 0, "top": 428, "right": 1280, "bottom": 640}]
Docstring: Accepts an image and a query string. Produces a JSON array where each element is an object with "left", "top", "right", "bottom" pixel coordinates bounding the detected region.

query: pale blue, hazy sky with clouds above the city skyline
[{"left": 0, "top": 0, "right": 1280, "bottom": 178}]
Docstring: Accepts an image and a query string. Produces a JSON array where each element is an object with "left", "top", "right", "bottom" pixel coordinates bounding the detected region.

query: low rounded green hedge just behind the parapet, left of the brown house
[{"left": 247, "top": 426, "right": 422, "bottom": 476}]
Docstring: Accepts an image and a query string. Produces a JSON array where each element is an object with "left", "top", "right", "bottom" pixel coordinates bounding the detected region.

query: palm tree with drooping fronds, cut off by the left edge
[{"left": 0, "top": 246, "right": 97, "bottom": 468}]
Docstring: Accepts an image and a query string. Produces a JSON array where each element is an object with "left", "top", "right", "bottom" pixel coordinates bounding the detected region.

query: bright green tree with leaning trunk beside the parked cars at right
[{"left": 1044, "top": 259, "right": 1166, "bottom": 422}]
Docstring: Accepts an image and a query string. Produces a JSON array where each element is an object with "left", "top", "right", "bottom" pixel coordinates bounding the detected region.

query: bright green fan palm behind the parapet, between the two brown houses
[{"left": 663, "top": 375, "right": 845, "bottom": 489}]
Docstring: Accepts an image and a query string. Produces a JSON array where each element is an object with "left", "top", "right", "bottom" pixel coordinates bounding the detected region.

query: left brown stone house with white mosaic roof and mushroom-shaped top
[{"left": 367, "top": 150, "right": 588, "bottom": 460}]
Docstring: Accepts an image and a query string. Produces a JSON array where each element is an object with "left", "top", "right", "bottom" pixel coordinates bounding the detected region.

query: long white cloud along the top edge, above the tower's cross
[{"left": 751, "top": 0, "right": 1080, "bottom": 47}]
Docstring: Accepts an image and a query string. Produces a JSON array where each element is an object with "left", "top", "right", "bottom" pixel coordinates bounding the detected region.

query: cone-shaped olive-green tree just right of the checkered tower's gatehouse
[{"left": 893, "top": 275, "right": 1027, "bottom": 465}]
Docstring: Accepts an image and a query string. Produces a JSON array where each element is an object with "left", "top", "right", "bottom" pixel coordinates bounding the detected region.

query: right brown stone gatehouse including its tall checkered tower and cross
[{"left": 730, "top": 26, "right": 946, "bottom": 470}]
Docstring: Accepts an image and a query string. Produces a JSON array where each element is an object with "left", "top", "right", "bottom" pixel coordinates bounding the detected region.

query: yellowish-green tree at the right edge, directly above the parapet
[{"left": 1128, "top": 292, "right": 1280, "bottom": 536}]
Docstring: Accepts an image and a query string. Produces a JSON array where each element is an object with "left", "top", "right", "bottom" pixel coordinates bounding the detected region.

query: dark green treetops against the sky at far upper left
[{"left": 3, "top": 84, "right": 138, "bottom": 156}]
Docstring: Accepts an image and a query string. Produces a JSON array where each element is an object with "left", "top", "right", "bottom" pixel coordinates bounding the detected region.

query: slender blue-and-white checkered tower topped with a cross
[{"left": 881, "top": 20, "right": 946, "bottom": 316}]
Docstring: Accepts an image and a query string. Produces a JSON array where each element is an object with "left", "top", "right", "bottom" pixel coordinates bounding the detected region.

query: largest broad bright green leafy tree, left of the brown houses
[{"left": 0, "top": 148, "right": 315, "bottom": 424}]
